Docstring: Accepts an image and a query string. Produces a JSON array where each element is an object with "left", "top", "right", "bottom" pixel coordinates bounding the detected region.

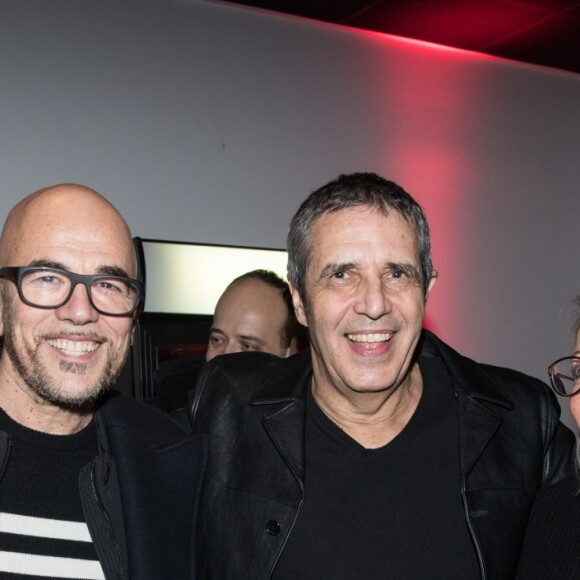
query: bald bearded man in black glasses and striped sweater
[{"left": 0, "top": 184, "right": 205, "bottom": 580}]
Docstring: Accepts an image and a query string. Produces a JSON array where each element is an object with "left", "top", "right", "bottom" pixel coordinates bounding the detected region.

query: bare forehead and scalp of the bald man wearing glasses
[{"left": 0, "top": 191, "right": 136, "bottom": 276}]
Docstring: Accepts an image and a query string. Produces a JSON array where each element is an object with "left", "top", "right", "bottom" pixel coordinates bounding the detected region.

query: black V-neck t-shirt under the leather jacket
[{"left": 273, "top": 358, "right": 481, "bottom": 580}]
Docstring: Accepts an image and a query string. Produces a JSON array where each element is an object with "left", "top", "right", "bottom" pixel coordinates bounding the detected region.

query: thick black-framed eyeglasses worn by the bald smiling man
[{"left": 0, "top": 266, "right": 143, "bottom": 316}]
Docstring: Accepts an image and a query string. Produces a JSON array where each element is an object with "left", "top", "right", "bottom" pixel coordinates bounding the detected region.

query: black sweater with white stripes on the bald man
[{"left": 0, "top": 409, "right": 103, "bottom": 580}]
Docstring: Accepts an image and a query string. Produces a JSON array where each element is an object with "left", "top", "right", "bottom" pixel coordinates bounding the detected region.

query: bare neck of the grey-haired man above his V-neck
[{"left": 312, "top": 364, "right": 423, "bottom": 449}]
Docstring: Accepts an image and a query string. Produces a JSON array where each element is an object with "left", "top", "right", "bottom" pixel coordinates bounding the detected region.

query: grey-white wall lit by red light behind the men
[{"left": 0, "top": 0, "right": 580, "bottom": 426}]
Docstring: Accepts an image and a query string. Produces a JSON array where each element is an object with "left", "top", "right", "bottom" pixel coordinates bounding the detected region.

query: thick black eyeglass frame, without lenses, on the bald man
[{"left": 0, "top": 266, "right": 145, "bottom": 317}]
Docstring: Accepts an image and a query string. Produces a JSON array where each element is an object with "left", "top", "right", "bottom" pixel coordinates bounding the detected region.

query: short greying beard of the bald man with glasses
[{"left": 2, "top": 296, "right": 123, "bottom": 408}]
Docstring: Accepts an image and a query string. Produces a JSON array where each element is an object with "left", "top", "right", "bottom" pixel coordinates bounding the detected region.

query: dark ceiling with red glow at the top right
[{"left": 221, "top": 0, "right": 580, "bottom": 73}]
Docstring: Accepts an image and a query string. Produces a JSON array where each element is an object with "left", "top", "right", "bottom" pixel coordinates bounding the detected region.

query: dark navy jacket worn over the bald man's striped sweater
[{"left": 0, "top": 392, "right": 206, "bottom": 580}]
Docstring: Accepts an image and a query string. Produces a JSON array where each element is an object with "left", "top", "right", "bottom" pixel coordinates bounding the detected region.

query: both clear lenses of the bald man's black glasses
[{"left": 21, "top": 269, "right": 138, "bottom": 314}]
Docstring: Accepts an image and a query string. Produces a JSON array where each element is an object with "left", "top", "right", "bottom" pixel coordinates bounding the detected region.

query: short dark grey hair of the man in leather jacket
[{"left": 287, "top": 173, "right": 433, "bottom": 304}]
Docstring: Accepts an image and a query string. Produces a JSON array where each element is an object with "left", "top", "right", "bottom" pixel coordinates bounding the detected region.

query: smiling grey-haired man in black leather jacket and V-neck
[{"left": 188, "top": 173, "right": 573, "bottom": 580}]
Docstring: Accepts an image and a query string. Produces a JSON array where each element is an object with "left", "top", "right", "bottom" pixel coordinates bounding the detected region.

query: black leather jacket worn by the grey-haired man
[{"left": 189, "top": 331, "right": 573, "bottom": 580}]
